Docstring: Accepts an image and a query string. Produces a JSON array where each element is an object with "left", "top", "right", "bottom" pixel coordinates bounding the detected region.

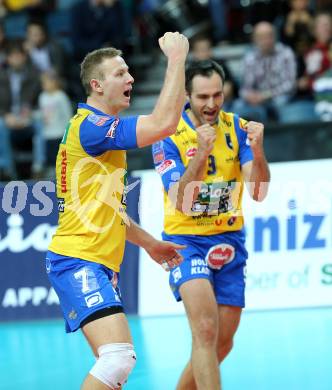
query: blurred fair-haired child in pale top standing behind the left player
[{"left": 38, "top": 71, "right": 73, "bottom": 175}]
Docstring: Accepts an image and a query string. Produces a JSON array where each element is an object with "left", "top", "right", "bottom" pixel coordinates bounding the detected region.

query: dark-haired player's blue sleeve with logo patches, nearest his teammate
[{"left": 152, "top": 138, "right": 186, "bottom": 192}]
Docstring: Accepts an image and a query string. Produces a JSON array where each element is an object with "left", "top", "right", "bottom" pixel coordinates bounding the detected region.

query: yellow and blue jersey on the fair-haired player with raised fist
[{"left": 49, "top": 103, "right": 137, "bottom": 272}]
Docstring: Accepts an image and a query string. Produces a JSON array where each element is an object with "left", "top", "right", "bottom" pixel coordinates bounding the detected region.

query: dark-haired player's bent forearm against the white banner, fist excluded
[{"left": 249, "top": 152, "right": 270, "bottom": 202}]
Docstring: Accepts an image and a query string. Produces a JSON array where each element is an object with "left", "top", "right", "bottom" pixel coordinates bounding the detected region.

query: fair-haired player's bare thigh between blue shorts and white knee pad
[{"left": 82, "top": 313, "right": 133, "bottom": 356}]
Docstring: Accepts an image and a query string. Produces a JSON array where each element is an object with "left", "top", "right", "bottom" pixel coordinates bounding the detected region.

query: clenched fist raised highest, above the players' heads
[{"left": 158, "top": 32, "right": 189, "bottom": 61}]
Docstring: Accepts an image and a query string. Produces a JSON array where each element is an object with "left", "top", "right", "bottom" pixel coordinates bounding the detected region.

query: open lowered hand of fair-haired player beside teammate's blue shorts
[{"left": 146, "top": 240, "right": 186, "bottom": 271}]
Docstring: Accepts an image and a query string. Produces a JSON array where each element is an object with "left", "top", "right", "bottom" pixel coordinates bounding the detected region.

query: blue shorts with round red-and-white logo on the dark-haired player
[{"left": 162, "top": 231, "right": 248, "bottom": 307}]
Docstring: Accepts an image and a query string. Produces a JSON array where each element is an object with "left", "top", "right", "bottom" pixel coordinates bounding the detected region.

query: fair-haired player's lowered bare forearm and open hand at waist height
[{"left": 126, "top": 218, "right": 185, "bottom": 268}]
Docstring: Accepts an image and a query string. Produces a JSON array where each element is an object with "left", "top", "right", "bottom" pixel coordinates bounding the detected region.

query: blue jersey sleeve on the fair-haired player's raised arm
[{"left": 80, "top": 114, "right": 138, "bottom": 157}]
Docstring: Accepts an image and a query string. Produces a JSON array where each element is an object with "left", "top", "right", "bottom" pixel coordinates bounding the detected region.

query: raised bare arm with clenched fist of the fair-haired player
[{"left": 136, "top": 33, "right": 189, "bottom": 147}]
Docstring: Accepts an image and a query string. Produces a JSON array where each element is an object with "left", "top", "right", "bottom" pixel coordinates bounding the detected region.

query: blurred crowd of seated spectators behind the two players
[{"left": 0, "top": 0, "right": 332, "bottom": 180}]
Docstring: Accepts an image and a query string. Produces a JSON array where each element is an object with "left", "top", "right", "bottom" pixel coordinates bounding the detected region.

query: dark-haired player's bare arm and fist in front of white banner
[{"left": 242, "top": 122, "right": 270, "bottom": 202}]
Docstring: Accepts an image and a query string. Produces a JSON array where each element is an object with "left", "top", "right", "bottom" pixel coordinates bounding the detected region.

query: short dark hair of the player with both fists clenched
[{"left": 186, "top": 60, "right": 225, "bottom": 93}]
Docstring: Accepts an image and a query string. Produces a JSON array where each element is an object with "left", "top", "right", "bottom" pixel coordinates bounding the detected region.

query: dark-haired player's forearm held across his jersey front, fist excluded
[{"left": 173, "top": 153, "right": 207, "bottom": 212}]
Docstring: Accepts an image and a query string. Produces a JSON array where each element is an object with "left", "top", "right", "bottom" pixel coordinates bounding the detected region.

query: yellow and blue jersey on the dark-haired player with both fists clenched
[{"left": 152, "top": 104, "right": 253, "bottom": 236}]
